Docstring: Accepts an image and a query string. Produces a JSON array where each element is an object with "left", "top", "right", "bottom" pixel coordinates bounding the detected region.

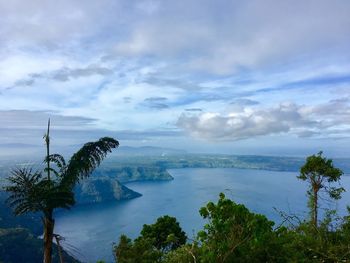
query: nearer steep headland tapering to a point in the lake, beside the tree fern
[{"left": 74, "top": 177, "right": 141, "bottom": 205}]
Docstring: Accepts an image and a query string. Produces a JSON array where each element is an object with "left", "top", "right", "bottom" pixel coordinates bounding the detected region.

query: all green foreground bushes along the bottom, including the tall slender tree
[{"left": 114, "top": 152, "right": 350, "bottom": 263}]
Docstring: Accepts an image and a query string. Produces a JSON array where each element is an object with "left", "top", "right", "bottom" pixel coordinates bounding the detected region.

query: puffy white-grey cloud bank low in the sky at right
[{"left": 177, "top": 99, "right": 350, "bottom": 140}]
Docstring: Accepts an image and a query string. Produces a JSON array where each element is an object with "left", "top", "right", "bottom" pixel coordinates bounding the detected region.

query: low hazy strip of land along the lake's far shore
[{"left": 96, "top": 155, "right": 350, "bottom": 175}]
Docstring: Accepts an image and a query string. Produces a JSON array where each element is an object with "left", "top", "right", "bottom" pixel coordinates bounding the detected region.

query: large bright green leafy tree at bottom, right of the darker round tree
[{"left": 198, "top": 193, "right": 283, "bottom": 263}]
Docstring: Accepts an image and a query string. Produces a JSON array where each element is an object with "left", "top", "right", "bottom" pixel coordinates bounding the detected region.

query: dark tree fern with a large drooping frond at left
[{"left": 5, "top": 121, "right": 119, "bottom": 263}]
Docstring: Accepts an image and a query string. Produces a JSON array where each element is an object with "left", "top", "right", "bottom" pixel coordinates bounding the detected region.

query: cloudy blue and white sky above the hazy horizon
[{"left": 0, "top": 0, "right": 350, "bottom": 157}]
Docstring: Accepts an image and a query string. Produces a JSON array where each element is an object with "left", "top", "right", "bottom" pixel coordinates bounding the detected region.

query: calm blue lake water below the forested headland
[{"left": 55, "top": 168, "right": 350, "bottom": 262}]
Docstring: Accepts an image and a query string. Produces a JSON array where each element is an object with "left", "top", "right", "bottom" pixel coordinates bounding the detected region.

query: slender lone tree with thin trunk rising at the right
[{"left": 298, "top": 152, "right": 345, "bottom": 228}]
